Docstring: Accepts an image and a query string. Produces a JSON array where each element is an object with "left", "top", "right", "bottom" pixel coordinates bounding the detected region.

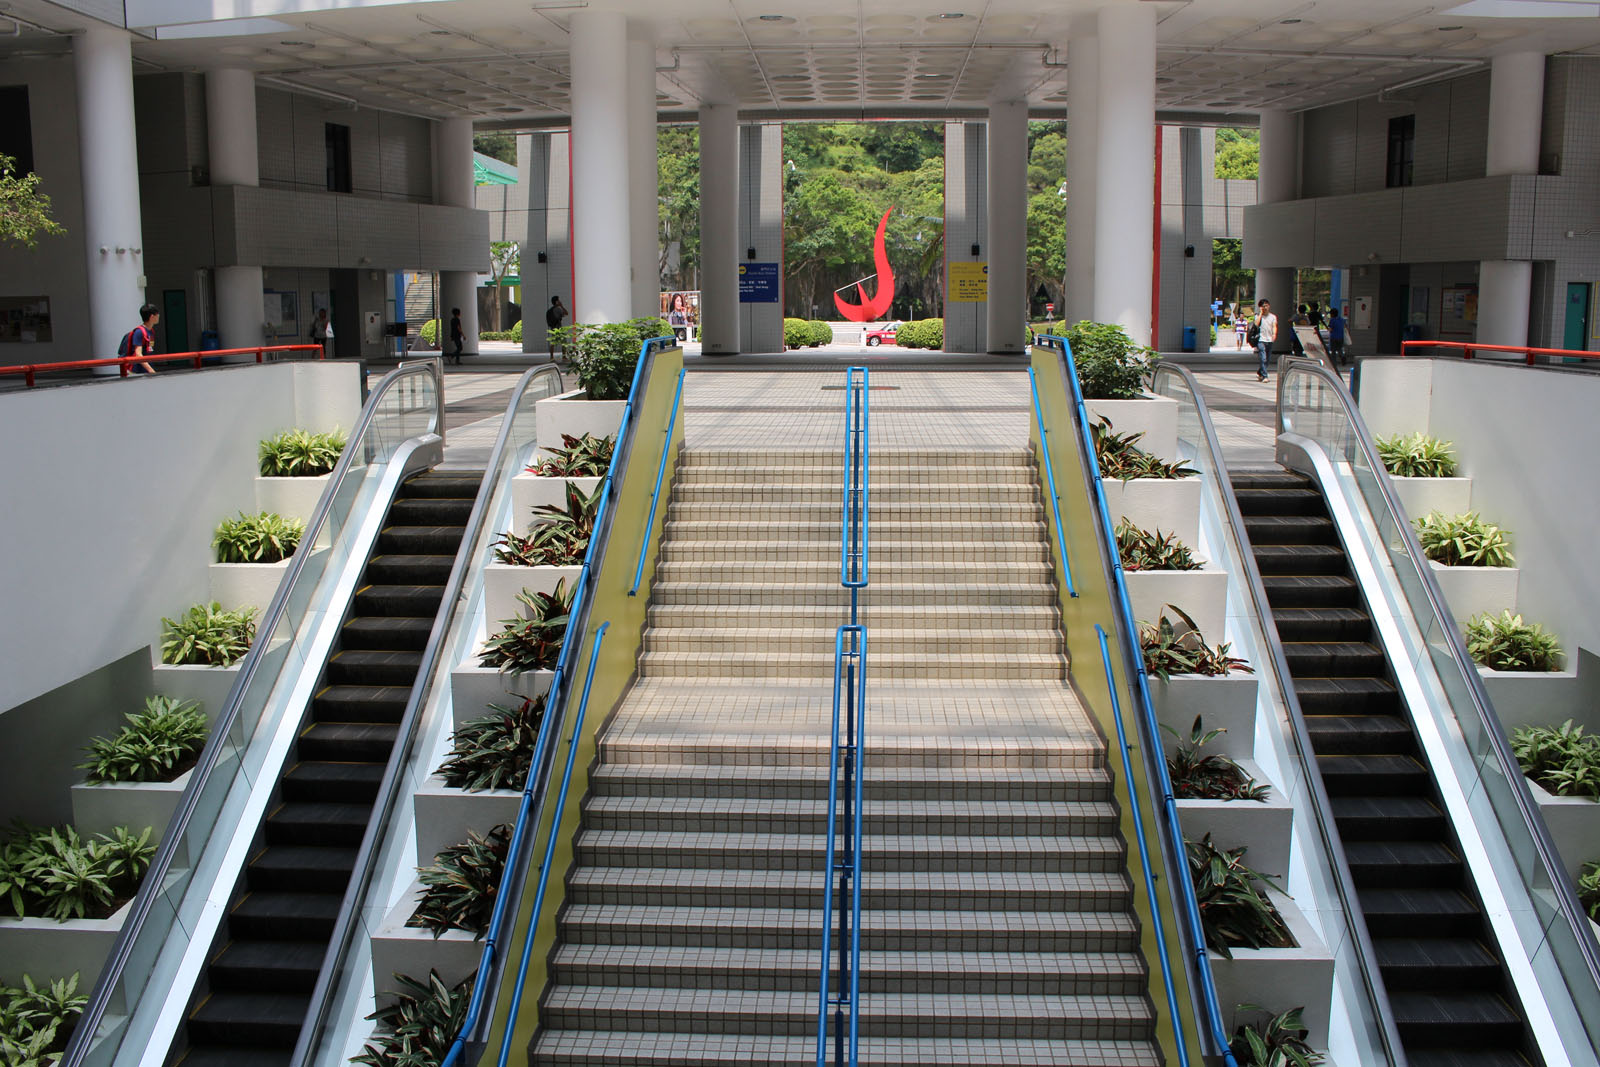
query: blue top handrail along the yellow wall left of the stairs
[{"left": 440, "top": 336, "right": 677, "bottom": 1067}]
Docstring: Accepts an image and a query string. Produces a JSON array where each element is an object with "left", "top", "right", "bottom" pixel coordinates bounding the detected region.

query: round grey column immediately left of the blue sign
[{"left": 701, "top": 102, "right": 739, "bottom": 355}]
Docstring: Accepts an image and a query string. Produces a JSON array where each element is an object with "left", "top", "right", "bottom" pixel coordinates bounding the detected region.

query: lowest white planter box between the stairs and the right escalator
[{"left": 1208, "top": 889, "right": 1333, "bottom": 1048}]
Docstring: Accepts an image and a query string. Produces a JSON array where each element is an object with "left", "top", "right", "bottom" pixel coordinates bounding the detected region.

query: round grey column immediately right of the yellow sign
[{"left": 989, "top": 99, "right": 1024, "bottom": 352}]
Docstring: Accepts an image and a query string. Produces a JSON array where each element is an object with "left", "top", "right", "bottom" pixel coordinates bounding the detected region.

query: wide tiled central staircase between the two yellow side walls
[{"left": 533, "top": 450, "right": 1162, "bottom": 1067}]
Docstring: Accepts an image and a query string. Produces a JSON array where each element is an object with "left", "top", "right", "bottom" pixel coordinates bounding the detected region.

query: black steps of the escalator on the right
[{"left": 1232, "top": 470, "right": 1542, "bottom": 1067}]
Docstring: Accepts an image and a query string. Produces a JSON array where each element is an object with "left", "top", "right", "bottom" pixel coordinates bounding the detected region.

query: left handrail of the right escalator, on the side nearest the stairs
[{"left": 1152, "top": 363, "right": 1406, "bottom": 1067}]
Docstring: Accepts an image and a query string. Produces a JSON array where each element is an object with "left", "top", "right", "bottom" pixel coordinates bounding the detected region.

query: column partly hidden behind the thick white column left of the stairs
[{"left": 627, "top": 21, "right": 661, "bottom": 317}]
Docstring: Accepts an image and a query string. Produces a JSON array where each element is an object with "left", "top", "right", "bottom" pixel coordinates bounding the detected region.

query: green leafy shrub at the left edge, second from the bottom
[{"left": 0, "top": 824, "right": 155, "bottom": 923}]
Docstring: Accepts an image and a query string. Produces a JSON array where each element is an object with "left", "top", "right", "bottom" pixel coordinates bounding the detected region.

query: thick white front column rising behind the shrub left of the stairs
[{"left": 571, "top": 8, "right": 634, "bottom": 323}]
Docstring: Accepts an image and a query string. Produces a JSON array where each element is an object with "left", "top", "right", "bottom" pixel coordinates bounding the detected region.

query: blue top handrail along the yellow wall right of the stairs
[{"left": 1042, "top": 336, "right": 1237, "bottom": 1067}]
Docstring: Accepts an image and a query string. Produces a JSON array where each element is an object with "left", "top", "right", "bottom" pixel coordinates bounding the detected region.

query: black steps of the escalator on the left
[{"left": 171, "top": 470, "right": 483, "bottom": 1067}]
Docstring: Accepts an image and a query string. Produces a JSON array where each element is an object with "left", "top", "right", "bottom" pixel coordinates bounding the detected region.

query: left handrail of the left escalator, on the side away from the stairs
[{"left": 59, "top": 358, "right": 445, "bottom": 1067}]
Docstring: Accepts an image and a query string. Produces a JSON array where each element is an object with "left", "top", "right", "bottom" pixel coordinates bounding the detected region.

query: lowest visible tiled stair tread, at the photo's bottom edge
[{"left": 533, "top": 1030, "right": 1162, "bottom": 1067}]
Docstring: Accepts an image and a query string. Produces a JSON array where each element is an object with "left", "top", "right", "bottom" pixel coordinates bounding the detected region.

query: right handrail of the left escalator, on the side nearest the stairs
[{"left": 290, "top": 363, "right": 562, "bottom": 1067}]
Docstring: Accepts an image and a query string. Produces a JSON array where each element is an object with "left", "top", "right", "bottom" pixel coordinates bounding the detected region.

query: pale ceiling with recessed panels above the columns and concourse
[{"left": 9, "top": 0, "right": 1600, "bottom": 126}]
